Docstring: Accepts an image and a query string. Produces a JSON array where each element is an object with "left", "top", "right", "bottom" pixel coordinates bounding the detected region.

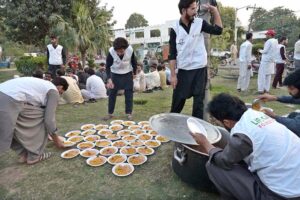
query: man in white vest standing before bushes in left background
[{"left": 47, "top": 35, "right": 67, "bottom": 77}]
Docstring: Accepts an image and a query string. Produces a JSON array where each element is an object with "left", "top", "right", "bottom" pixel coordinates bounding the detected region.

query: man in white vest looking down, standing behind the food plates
[{"left": 103, "top": 37, "right": 137, "bottom": 120}]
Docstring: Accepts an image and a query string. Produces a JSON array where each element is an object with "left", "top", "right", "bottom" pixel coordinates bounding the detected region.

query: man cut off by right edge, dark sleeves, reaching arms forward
[{"left": 258, "top": 70, "right": 300, "bottom": 137}]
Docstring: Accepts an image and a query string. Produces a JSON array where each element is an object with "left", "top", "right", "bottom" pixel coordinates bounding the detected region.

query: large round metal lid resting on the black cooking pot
[{"left": 149, "top": 113, "right": 222, "bottom": 145}]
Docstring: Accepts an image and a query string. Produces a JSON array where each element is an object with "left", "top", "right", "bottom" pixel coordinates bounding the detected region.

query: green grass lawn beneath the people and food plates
[{"left": 0, "top": 68, "right": 300, "bottom": 200}]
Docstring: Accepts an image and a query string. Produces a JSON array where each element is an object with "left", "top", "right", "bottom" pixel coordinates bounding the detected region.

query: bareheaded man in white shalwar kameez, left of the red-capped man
[{"left": 237, "top": 33, "right": 253, "bottom": 92}]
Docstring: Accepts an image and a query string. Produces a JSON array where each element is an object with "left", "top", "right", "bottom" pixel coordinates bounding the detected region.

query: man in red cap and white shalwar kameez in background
[{"left": 257, "top": 29, "right": 278, "bottom": 94}]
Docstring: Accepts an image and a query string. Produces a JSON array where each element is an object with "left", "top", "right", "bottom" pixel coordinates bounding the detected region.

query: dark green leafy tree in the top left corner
[{"left": 0, "top": 0, "right": 71, "bottom": 46}]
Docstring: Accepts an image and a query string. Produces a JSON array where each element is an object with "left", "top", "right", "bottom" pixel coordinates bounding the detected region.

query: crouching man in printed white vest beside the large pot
[{"left": 192, "top": 93, "right": 300, "bottom": 200}]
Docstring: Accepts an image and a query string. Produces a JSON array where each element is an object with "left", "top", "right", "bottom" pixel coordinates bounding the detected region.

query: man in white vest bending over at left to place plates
[{"left": 0, "top": 77, "right": 68, "bottom": 164}]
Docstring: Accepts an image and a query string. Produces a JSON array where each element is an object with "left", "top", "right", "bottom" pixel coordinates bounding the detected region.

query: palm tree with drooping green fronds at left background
[{"left": 50, "top": 0, "right": 114, "bottom": 66}]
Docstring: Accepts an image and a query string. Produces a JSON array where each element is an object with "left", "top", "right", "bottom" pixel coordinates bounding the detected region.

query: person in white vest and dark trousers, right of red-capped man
[{"left": 272, "top": 37, "right": 288, "bottom": 89}]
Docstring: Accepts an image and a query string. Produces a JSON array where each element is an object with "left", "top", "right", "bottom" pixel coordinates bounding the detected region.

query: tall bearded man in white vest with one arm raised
[{"left": 169, "top": 0, "right": 223, "bottom": 119}]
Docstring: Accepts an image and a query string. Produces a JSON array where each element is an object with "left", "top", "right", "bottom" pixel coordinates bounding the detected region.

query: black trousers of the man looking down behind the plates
[{"left": 108, "top": 72, "right": 133, "bottom": 114}]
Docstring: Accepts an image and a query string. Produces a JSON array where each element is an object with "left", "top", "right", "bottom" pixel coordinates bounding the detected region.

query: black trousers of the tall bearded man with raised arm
[{"left": 171, "top": 67, "right": 207, "bottom": 119}]
